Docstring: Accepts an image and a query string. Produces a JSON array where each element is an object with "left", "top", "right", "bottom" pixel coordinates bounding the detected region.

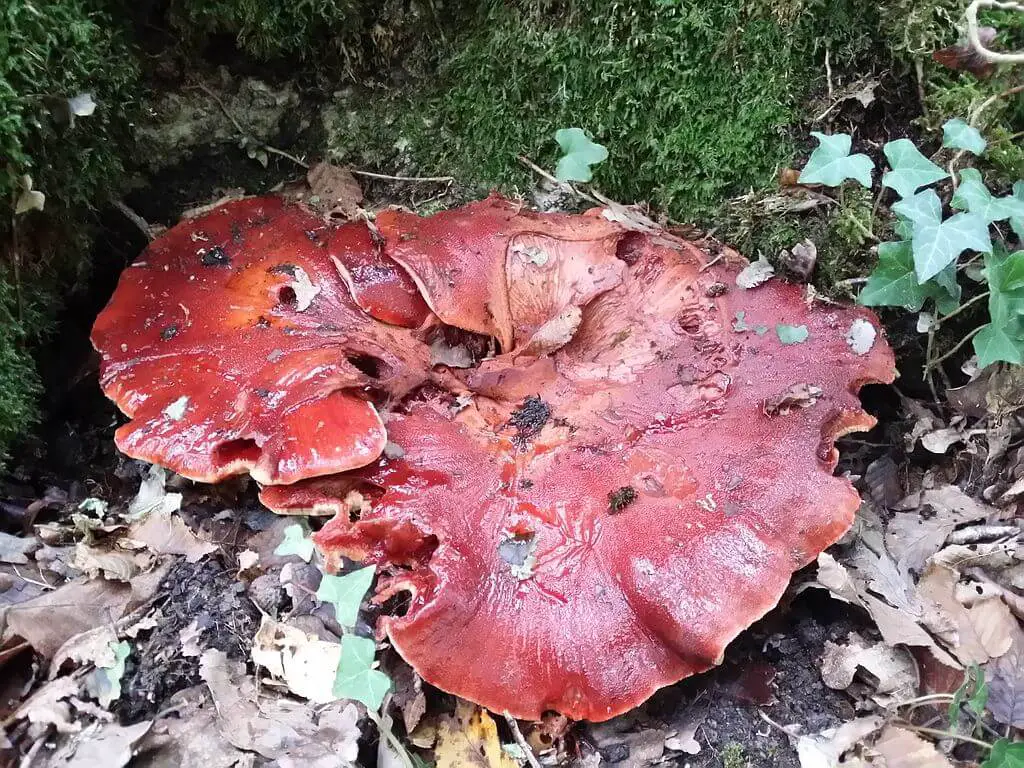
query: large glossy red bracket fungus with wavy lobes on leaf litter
[{"left": 93, "top": 197, "right": 894, "bottom": 720}]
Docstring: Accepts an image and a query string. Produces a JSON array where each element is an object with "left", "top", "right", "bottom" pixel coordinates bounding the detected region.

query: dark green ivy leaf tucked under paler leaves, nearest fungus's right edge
[{"left": 857, "top": 242, "right": 959, "bottom": 314}]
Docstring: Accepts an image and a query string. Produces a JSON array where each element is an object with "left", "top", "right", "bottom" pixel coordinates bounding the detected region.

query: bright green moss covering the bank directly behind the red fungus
[{"left": 327, "top": 0, "right": 876, "bottom": 219}]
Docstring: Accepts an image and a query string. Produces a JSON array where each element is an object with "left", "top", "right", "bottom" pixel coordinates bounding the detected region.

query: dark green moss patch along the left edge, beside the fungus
[{"left": 0, "top": 0, "right": 137, "bottom": 454}]
